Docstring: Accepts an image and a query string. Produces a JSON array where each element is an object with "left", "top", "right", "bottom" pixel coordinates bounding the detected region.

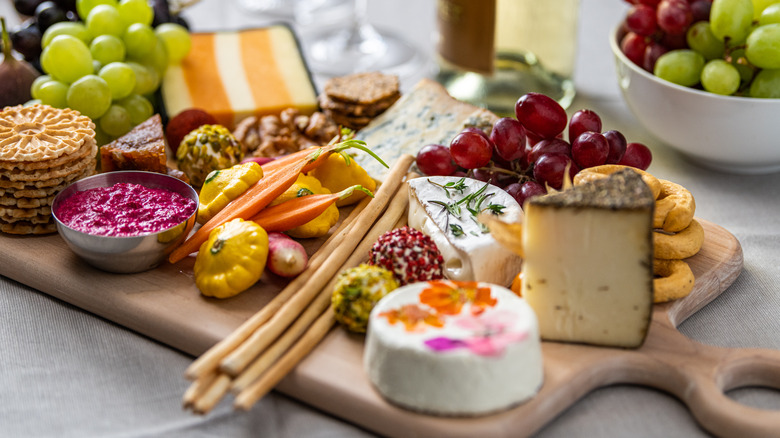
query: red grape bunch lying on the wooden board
[{"left": 417, "top": 93, "right": 652, "bottom": 205}]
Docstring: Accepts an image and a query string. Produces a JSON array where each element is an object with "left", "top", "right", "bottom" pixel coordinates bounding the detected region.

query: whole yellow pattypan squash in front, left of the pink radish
[{"left": 194, "top": 219, "right": 268, "bottom": 298}]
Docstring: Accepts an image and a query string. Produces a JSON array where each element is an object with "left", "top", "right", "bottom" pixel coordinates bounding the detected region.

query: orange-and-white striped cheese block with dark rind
[{"left": 162, "top": 25, "right": 317, "bottom": 129}]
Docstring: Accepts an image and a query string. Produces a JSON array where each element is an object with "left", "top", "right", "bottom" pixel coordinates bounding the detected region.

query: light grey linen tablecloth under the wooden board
[{"left": 0, "top": 0, "right": 780, "bottom": 437}]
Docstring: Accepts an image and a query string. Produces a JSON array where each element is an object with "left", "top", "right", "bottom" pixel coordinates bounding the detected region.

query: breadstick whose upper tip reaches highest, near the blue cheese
[{"left": 219, "top": 154, "right": 414, "bottom": 376}]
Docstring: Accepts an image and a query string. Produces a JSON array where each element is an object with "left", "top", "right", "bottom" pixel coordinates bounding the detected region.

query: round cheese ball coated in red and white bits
[{"left": 368, "top": 226, "right": 444, "bottom": 286}]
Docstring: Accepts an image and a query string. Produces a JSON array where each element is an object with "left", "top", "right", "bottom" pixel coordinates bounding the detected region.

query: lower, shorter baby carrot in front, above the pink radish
[{"left": 250, "top": 185, "right": 374, "bottom": 233}]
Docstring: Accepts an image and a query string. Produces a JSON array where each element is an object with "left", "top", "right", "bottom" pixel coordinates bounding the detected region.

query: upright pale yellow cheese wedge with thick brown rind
[{"left": 522, "top": 170, "right": 654, "bottom": 347}]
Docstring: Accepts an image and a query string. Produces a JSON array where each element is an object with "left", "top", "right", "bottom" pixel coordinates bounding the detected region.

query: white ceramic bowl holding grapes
[{"left": 610, "top": 28, "right": 780, "bottom": 174}]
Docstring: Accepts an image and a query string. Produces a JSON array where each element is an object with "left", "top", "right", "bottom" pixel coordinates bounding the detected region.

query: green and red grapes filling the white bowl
[{"left": 621, "top": 0, "right": 780, "bottom": 99}]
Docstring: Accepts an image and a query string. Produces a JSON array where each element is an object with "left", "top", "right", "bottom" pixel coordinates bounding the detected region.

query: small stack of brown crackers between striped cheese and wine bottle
[{"left": 319, "top": 72, "right": 401, "bottom": 131}]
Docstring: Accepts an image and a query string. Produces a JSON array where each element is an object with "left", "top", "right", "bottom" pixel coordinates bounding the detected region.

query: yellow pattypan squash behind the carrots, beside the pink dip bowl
[{"left": 198, "top": 162, "right": 263, "bottom": 224}]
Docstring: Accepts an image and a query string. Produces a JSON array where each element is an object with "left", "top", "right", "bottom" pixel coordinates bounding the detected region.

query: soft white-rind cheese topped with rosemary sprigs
[{"left": 408, "top": 176, "right": 523, "bottom": 286}]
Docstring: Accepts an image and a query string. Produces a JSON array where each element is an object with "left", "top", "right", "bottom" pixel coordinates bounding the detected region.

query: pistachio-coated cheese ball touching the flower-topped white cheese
[{"left": 331, "top": 264, "right": 398, "bottom": 333}]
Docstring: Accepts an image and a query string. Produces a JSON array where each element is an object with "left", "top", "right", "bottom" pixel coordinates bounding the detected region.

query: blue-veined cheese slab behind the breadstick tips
[{"left": 355, "top": 79, "right": 498, "bottom": 181}]
